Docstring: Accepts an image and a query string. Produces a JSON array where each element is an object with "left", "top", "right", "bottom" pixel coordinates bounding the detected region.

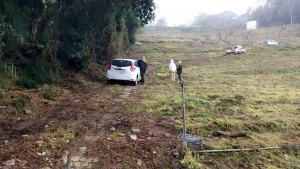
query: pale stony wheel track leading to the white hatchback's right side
[{"left": 62, "top": 86, "right": 138, "bottom": 168}]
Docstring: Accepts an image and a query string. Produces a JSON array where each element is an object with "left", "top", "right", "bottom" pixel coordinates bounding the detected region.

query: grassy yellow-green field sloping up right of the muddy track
[{"left": 132, "top": 25, "right": 300, "bottom": 168}]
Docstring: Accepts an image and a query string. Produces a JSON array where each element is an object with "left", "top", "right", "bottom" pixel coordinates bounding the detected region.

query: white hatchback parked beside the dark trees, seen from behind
[{"left": 107, "top": 59, "right": 142, "bottom": 86}]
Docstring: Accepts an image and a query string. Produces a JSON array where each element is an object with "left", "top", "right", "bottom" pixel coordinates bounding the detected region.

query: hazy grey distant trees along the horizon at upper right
[{"left": 190, "top": 0, "right": 300, "bottom": 31}]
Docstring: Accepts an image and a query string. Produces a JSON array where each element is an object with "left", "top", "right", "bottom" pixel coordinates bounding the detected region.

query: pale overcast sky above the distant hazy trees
[{"left": 154, "top": 0, "right": 258, "bottom": 26}]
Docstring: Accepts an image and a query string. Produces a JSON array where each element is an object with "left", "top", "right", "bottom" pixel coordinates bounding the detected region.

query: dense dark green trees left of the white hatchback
[{"left": 0, "top": 0, "right": 154, "bottom": 87}]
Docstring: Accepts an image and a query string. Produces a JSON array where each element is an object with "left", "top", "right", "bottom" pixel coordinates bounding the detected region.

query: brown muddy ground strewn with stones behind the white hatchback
[{"left": 0, "top": 80, "right": 181, "bottom": 168}]
